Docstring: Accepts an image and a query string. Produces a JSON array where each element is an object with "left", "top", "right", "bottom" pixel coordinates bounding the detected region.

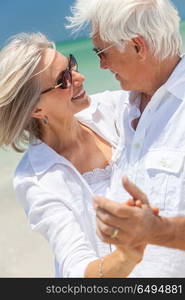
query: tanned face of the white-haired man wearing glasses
[{"left": 93, "top": 35, "right": 146, "bottom": 91}]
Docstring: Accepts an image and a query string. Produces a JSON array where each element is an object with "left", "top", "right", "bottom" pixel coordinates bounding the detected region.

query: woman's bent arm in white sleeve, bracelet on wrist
[{"left": 16, "top": 179, "right": 145, "bottom": 278}]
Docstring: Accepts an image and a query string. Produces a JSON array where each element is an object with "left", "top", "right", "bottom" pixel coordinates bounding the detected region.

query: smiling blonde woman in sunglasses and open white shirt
[{"left": 0, "top": 33, "right": 145, "bottom": 277}]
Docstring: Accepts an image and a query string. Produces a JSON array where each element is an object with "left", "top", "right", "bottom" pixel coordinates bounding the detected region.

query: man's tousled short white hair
[{"left": 66, "top": 0, "right": 182, "bottom": 60}]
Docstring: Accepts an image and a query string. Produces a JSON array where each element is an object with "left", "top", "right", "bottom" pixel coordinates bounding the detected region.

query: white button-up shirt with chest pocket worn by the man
[{"left": 107, "top": 56, "right": 185, "bottom": 277}]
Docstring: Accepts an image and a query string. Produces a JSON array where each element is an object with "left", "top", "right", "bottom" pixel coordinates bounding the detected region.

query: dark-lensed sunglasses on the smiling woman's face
[{"left": 41, "top": 54, "right": 78, "bottom": 94}]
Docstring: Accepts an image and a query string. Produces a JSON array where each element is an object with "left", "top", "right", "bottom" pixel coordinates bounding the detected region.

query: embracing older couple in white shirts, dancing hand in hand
[{"left": 0, "top": 0, "right": 185, "bottom": 278}]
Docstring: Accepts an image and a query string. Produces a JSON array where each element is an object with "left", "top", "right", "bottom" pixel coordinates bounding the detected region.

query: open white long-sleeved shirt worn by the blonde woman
[{"left": 14, "top": 91, "right": 123, "bottom": 278}]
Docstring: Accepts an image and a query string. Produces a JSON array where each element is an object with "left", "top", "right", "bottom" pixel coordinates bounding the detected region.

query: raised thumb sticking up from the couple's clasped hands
[{"left": 122, "top": 176, "right": 149, "bottom": 204}]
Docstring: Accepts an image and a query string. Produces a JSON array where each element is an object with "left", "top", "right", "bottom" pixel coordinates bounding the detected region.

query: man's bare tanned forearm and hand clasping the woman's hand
[{"left": 94, "top": 177, "right": 185, "bottom": 250}]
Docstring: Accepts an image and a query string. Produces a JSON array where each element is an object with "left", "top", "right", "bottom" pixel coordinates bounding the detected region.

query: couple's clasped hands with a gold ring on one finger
[{"left": 94, "top": 176, "right": 159, "bottom": 262}]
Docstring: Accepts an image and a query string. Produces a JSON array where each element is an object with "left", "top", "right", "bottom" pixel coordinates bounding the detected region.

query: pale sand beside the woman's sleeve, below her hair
[{"left": 0, "top": 150, "right": 54, "bottom": 278}]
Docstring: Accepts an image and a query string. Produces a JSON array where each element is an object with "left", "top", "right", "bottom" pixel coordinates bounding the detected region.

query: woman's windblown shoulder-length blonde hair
[{"left": 0, "top": 33, "right": 55, "bottom": 152}]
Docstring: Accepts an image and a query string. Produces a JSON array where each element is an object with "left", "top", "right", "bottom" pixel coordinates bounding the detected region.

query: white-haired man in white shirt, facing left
[{"left": 69, "top": 0, "right": 185, "bottom": 277}]
